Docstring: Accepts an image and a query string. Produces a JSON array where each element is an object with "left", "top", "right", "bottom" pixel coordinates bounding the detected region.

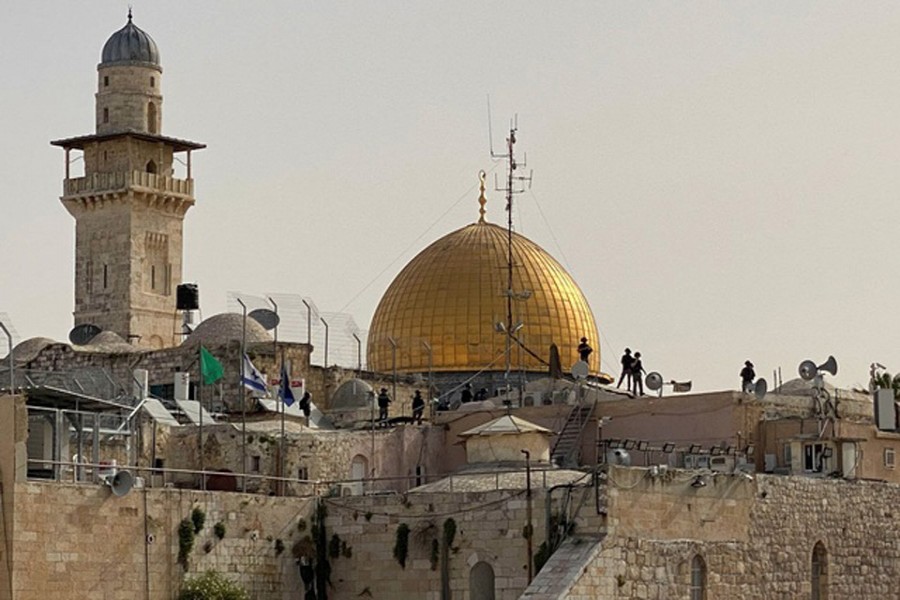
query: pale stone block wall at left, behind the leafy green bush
[{"left": 7, "top": 483, "right": 311, "bottom": 600}]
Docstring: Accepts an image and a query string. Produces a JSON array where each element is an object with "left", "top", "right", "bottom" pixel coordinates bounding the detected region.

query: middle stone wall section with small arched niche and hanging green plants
[{"left": 326, "top": 490, "right": 596, "bottom": 600}]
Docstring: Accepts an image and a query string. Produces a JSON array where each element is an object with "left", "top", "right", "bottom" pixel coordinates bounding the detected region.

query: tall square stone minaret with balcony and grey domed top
[{"left": 51, "top": 10, "right": 205, "bottom": 348}]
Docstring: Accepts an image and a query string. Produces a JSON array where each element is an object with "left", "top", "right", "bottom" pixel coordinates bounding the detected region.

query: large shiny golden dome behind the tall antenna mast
[{"left": 367, "top": 218, "right": 600, "bottom": 373}]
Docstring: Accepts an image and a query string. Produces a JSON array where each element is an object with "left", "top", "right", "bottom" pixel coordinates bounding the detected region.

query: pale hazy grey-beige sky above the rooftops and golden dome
[{"left": 0, "top": 0, "right": 900, "bottom": 390}]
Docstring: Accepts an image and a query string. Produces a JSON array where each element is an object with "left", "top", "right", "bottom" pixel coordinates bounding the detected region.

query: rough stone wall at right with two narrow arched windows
[{"left": 540, "top": 469, "right": 900, "bottom": 600}]
